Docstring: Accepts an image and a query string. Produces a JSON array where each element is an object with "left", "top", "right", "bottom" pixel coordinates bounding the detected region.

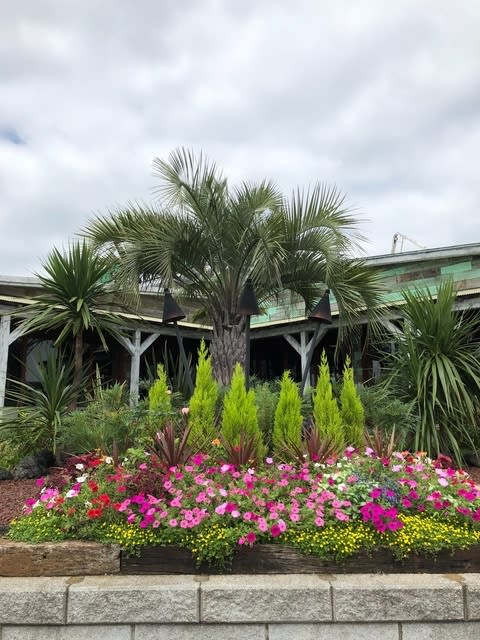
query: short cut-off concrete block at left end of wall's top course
[{"left": 0, "top": 578, "right": 67, "bottom": 624}]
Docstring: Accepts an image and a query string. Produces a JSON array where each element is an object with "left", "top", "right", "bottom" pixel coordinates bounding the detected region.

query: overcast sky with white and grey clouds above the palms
[{"left": 0, "top": 0, "right": 480, "bottom": 275}]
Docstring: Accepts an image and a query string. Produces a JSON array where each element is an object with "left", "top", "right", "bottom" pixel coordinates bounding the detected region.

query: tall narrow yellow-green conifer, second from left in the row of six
[{"left": 189, "top": 340, "right": 218, "bottom": 446}]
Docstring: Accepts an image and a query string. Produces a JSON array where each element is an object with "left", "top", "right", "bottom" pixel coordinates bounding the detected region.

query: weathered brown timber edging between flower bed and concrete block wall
[{"left": 0, "top": 539, "right": 480, "bottom": 577}]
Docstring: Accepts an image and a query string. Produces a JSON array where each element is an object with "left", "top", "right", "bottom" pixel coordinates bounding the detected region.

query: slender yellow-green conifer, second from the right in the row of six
[{"left": 313, "top": 351, "right": 345, "bottom": 450}]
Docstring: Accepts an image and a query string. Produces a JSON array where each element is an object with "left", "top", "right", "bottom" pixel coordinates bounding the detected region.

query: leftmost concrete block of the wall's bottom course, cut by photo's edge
[{"left": 0, "top": 625, "right": 132, "bottom": 640}]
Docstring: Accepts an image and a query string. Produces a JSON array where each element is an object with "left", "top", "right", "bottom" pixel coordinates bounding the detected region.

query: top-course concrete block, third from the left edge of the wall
[{"left": 200, "top": 574, "right": 332, "bottom": 623}]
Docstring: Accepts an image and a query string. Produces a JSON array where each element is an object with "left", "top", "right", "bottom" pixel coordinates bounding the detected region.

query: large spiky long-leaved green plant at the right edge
[{"left": 387, "top": 280, "right": 480, "bottom": 464}]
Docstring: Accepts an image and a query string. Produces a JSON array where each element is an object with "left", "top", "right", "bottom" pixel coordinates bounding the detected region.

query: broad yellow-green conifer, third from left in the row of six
[{"left": 222, "top": 362, "right": 263, "bottom": 455}]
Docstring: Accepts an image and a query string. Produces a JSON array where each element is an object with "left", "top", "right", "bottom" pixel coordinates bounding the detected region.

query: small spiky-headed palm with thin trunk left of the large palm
[{"left": 21, "top": 240, "right": 126, "bottom": 408}]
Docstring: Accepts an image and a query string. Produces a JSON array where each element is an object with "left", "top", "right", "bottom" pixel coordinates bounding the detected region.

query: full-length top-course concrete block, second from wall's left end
[{"left": 67, "top": 575, "right": 199, "bottom": 624}]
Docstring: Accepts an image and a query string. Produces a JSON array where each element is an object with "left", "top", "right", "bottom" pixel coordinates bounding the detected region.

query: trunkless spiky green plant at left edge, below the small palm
[{"left": 0, "top": 351, "right": 75, "bottom": 454}]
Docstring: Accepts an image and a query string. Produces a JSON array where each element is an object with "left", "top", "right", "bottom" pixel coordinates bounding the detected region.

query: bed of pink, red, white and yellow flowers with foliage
[{"left": 9, "top": 448, "right": 480, "bottom": 572}]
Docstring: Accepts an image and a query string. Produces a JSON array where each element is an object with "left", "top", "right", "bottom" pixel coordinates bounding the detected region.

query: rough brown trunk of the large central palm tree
[{"left": 210, "top": 325, "right": 245, "bottom": 386}]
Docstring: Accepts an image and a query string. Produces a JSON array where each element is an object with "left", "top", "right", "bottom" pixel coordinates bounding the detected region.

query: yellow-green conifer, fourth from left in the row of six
[{"left": 273, "top": 371, "right": 303, "bottom": 453}]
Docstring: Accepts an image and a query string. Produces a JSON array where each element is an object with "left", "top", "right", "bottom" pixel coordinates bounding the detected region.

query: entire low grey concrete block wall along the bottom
[{"left": 0, "top": 573, "right": 480, "bottom": 640}]
